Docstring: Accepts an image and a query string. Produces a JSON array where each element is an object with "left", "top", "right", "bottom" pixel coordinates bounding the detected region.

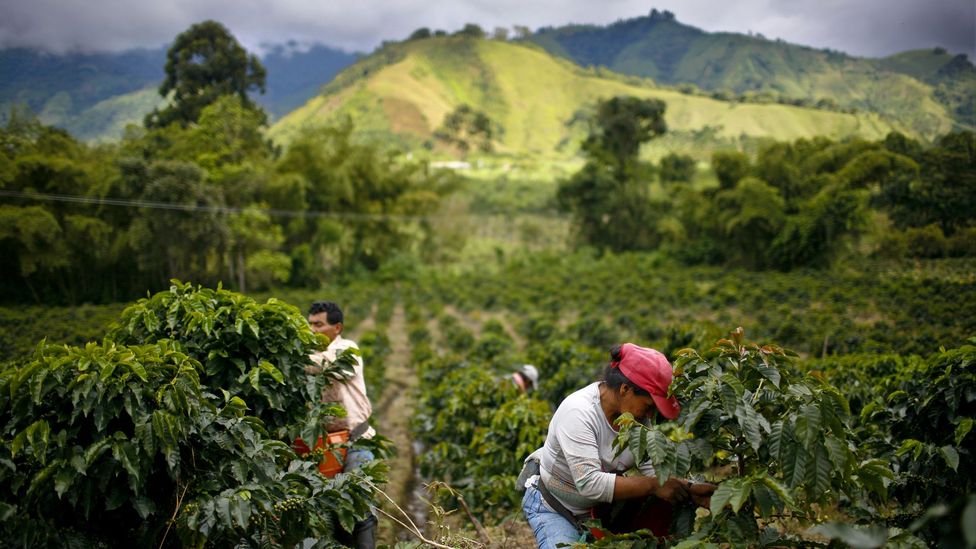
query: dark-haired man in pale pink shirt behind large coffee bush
[{"left": 305, "top": 301, "right": 377, "bottom": 549}]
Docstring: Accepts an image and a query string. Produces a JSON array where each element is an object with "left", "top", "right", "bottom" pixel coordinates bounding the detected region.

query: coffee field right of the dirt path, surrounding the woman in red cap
[{"left": 400, "top": 256, "right": 976, "bottom": 547}]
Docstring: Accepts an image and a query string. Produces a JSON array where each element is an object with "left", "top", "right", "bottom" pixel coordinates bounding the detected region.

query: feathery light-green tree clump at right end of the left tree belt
[{"left": 277, "top": 121, "right": 445, "bottom": 274}]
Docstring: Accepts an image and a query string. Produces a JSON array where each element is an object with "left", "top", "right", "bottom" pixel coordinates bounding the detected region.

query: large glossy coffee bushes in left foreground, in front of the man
[{"left": 0, "top": 284, "right": 387, "bottom": 547}]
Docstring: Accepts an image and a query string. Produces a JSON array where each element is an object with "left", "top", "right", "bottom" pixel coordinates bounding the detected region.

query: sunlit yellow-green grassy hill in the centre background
[{"left": 271, "top": 36, "right": 915, "bottom": 154}]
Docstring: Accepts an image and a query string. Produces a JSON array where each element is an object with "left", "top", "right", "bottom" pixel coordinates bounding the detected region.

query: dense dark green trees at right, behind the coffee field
[{"left": 557, "top": 117, "right": 976, "bottom": 270}]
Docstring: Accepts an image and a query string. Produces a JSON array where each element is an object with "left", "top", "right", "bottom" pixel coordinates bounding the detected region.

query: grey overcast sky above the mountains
[{"left": 0, "top": 0, "right": 976, "bottom": 59}]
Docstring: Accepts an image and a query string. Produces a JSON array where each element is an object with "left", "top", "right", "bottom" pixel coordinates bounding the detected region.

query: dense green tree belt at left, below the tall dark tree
[{"left": 0, "top": 100, "right": 447, "bottom": 303}]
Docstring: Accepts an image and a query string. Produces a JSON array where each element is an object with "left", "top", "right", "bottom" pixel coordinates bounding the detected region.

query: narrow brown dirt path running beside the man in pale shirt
[{"left": 373, "top": 304, "right": 417, "bottom": 545}]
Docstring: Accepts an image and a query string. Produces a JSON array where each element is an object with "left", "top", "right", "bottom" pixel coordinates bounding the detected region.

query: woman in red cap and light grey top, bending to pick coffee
[{"left": 520, "top": 343, "right": 715, "bottom": 549}]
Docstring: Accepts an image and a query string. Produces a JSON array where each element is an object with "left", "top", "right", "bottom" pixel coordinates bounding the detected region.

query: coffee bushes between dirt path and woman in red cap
[{"left": 411, "top": 306, "right": 552, "bottom": 522}]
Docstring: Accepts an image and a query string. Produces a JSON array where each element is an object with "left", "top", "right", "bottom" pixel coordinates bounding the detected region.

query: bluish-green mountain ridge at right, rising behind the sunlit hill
[{"left": 529, "top": 10, "right": 960, "bottom": 139}]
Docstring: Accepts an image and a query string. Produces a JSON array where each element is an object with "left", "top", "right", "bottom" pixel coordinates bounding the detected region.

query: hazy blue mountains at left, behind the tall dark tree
[{"left": 0, "top": 43, "right": 357, "bottom": 141}]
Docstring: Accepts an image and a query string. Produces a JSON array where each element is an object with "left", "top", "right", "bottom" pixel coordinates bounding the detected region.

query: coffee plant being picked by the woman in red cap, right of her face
[{"left": 617, "top": 329, "right": 912, "bottom": 546}]
